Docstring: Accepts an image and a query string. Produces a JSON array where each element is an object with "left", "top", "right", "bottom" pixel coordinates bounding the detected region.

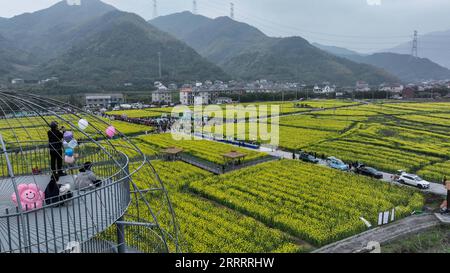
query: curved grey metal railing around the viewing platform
[{"left": 0, "top": 143, "right": 131, "bottom": 253}]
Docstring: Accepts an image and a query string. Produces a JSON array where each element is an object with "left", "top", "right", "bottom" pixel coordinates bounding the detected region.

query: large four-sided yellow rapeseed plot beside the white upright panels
[{"left": 189, "top": 160, "right": 424, "bottom": 246}]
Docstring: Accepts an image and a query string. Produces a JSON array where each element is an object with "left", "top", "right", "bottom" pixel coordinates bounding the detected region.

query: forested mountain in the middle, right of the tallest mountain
[{"left": 150, "top": 12, "right": 399, "bottom": 85}]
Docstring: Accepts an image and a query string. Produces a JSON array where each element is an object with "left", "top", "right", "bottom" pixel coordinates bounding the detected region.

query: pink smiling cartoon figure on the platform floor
[{"left": 11, "top": 184, "right": 45, "bottom": 210}]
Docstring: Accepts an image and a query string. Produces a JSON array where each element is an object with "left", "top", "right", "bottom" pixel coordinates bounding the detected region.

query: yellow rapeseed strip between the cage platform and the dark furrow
[{"left": 126, "top": 161, "right": 310, "bottom": 253}]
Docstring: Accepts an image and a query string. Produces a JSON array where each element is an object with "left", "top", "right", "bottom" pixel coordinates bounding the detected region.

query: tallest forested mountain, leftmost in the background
[{"left": 0, "top": 0, "right": 229, "bottom": 87}]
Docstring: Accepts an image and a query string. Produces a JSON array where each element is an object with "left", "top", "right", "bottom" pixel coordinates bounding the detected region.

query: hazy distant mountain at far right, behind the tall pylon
[{"left": 315, "top": 44, "right": 450, "bottom": 83}]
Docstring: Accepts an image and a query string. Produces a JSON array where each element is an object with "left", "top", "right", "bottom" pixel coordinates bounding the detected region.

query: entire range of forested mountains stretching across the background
[{"left": 0, "top": 0, "right": 450, "bottom": 88}]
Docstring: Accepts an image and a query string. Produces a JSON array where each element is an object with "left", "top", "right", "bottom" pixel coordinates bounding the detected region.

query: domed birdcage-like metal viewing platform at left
[{"left": 0, "top": 90, "right": 180, "bottom": 253}]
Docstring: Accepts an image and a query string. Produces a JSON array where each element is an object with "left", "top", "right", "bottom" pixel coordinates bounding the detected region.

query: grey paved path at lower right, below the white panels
[{"left": 313, "top": 214, "right": 440, "bottom": 253}]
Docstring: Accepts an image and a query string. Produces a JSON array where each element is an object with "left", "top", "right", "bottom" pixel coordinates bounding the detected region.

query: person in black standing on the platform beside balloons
[{"left": 47, "top": 121, "right": 66, "bottom": 176}]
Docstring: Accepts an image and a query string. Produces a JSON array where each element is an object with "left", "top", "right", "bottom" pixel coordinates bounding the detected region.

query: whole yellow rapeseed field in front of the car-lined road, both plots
[{"left": 124, "top": 160, "right": 424, "bottom": 253}]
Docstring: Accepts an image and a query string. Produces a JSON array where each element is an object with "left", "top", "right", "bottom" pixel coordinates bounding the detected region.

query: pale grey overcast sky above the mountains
[{"left": 0, "top": 0, "right": 450, "bottom": 52}]
